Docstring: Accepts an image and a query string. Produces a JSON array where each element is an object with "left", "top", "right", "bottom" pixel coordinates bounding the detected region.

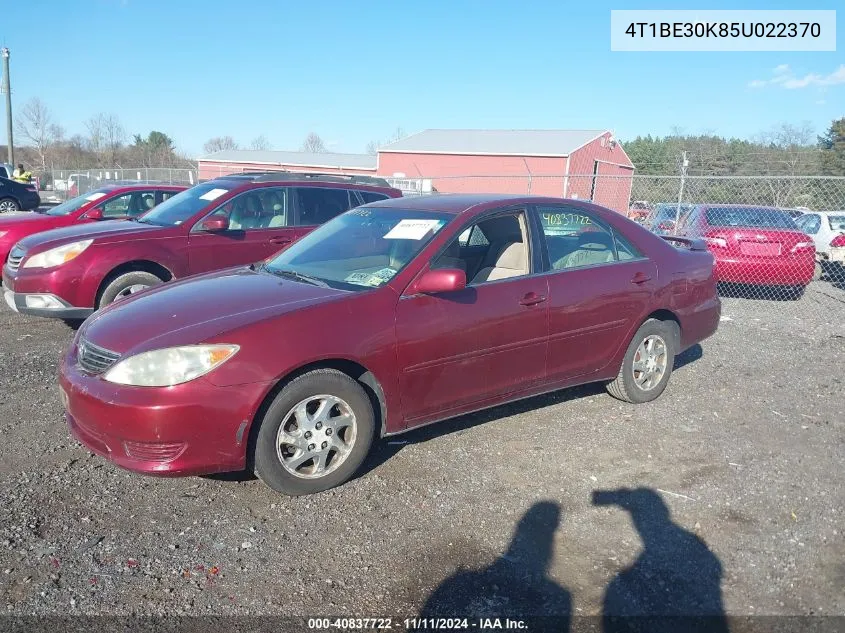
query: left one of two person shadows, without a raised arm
[{"left": 420, "top": 501, "right": 572, "bottom": 633}]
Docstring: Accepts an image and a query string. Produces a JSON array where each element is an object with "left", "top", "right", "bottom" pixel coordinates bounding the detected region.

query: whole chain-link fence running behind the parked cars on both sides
[{"left": 26, "top": 167, "right": 845, "bottom": 302}]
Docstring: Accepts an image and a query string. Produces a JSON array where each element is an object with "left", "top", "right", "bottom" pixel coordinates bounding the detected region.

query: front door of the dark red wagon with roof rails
[{"left": 188, "top": 187, "right": 295, "bottom": 275}]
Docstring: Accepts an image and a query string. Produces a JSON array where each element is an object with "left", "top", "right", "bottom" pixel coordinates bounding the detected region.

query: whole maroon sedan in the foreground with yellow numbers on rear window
[{"left": 60, "top": 195, "right": 721, "bottom": 495}]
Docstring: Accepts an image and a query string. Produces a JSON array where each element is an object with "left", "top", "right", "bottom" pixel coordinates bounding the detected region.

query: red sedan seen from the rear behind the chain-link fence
[{"left": 678, "top": 204, "right": 816, "bottom": 298}]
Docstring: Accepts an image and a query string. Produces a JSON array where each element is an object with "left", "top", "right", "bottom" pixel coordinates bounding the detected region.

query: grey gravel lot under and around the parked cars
[{"left": 0, "top": 281, "right": 845, "bottom": 618}]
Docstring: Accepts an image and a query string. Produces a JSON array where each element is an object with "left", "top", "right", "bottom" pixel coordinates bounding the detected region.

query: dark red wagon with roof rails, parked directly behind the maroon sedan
[{"left": 3, "top": 172, "right": 402, "bottom": 319}]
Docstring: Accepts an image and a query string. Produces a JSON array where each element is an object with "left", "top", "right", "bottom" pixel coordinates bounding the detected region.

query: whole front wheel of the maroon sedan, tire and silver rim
[{"left": 254, "top": 369, "right": 375, "bottom": 496}]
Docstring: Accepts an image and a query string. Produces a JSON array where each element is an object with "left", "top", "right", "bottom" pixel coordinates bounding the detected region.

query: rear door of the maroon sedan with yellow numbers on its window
[{"left": 536, "top": 205, "right": 657, "bottom": 382}]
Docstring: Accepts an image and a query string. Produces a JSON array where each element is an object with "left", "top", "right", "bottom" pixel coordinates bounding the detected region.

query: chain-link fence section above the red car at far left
[{"left": 38, "top": 167, "right": 197, "bottom": 203}]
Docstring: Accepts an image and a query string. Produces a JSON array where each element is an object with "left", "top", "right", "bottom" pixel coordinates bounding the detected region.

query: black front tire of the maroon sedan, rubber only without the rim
[{"left": 254, "top": 369, "right": 375, "bottom": 496}]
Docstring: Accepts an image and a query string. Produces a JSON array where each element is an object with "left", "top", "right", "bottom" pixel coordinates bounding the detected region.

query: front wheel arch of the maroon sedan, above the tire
[{"left": 246, "top": 357, "right": 387, "bottom": 472}]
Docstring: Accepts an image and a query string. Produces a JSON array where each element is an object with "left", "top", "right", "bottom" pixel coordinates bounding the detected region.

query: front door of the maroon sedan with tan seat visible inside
[{"left": 396, "top": 208, "right": 548, "bottom": 426}]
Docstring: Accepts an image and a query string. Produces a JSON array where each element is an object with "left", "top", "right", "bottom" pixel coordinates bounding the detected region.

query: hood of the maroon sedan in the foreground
[{"left": 81, "top": 268, "right": 350, "bottom": 354}]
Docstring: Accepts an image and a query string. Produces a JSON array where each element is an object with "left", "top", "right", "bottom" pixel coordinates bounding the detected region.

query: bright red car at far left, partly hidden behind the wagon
[{"left": 0, "top": 183, "right": 185, "bottom": 262}]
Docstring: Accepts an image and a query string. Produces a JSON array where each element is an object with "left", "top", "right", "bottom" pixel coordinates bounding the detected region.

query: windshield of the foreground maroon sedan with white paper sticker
[{"left": 263, "top": 207, "right": 454, "bottom": 290}]
